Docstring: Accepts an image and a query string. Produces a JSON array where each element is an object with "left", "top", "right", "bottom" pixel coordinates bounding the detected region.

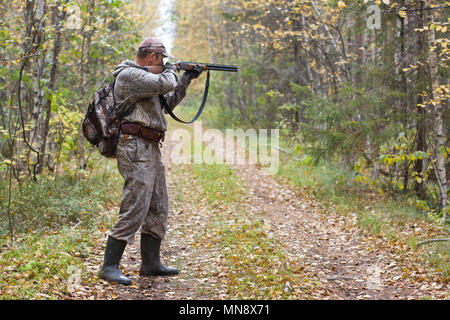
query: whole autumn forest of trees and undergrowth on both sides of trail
[{"left": 0, "top": 0, "right": 450, "bottom": 300}]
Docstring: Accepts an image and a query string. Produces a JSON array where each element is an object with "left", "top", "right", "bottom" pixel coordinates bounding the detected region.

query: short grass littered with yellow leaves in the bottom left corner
[{"left": 0, "top": 227, "right": 94, "bottom": 299}]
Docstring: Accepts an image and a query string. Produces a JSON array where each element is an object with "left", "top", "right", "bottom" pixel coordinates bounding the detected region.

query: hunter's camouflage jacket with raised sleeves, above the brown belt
[{"left": 112, "top": 60, "right": 191, "bottom": 131}]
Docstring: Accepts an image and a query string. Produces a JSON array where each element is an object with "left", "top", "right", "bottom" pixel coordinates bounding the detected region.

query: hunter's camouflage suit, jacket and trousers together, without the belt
[{"left": 109, "top": 60, "right": 190, "bottom": 242}]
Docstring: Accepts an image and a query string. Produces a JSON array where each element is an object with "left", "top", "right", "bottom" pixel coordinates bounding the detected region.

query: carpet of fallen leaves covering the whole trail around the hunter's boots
[{"left": 0, "top": 126, "right": 449, "bottom": 299}]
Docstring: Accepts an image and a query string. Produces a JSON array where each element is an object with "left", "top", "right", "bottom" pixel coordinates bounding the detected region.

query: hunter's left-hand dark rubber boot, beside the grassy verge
[{"left": 100, "top": 236, "right": 131, "bottom": 286}]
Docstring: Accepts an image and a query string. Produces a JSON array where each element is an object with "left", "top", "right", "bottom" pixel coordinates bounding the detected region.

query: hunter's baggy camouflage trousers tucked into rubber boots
[{"left": 109, "top": 134, "right": 169, "bottom": 243}]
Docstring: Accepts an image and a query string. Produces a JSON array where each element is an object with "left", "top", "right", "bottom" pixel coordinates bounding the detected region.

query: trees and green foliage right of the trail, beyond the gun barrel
[{"left": 175, "top": 0, "right": 449, "bottom": 216}]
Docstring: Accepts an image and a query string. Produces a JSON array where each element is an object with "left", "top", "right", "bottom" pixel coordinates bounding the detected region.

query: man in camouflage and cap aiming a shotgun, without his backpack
[{"left": 100, "top": 38, "right": 237, "bottom": 285}]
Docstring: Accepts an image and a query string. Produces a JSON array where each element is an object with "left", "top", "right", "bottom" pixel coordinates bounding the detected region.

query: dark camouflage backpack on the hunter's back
[{"left": 82, "top": 69, "right": 133, "bottom": 158}]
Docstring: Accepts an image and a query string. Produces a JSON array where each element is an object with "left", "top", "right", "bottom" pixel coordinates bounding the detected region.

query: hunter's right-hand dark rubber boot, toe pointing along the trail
[{"left": 139, "top": 233, "right": 178, "bottom": 276}]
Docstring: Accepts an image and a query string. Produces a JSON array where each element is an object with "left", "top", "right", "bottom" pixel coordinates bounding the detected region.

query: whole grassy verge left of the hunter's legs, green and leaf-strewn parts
[{"left": 0, "top": 158, "right": 122, "bottom": 300}]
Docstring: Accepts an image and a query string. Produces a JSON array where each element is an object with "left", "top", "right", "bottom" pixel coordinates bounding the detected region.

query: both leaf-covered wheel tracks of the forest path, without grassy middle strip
[{"left": 74, "top": 125, "right": 449, "bottom": 300}]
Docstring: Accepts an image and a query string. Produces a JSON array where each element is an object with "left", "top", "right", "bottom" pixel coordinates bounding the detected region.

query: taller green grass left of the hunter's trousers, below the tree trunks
[{"left": 0, "top": 158, "right": 121, "bottom": 235}]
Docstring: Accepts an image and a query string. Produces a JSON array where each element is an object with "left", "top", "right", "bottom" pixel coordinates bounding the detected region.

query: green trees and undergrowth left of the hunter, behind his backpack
[{"left": 0, "top": 0, "right": 149, "bottom": 240}]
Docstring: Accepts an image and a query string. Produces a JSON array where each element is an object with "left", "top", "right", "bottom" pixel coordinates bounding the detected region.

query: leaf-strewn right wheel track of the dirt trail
[{"left": 234, "top": 165, "right": 449, "bottom": 299}]
